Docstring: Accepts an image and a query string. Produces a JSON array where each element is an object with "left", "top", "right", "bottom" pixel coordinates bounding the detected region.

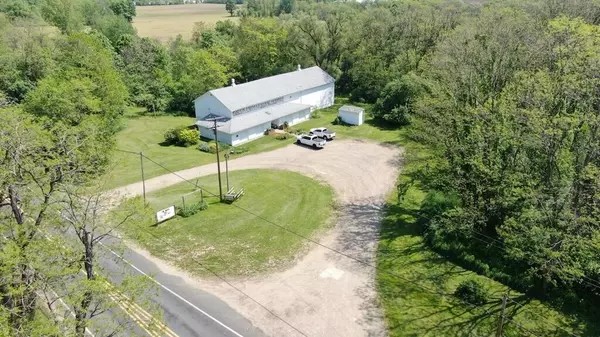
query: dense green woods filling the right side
[{"left": 410, "top": 1, "right": 600, "bottom": 311}]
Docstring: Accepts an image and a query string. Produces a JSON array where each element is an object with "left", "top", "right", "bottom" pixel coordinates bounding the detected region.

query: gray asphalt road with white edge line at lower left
[{"left": 98, "top": 239, "right": 266, "bottom": 337}]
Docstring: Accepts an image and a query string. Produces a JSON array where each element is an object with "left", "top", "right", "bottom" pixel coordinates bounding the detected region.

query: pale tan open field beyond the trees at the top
[{"left": 133, "top": 3, "right": 238, "bottom": 42}]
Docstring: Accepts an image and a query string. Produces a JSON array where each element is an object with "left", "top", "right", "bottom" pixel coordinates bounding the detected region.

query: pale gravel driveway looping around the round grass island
[{"left": 115, "top": 140, "right": 402, "bottom": 337}]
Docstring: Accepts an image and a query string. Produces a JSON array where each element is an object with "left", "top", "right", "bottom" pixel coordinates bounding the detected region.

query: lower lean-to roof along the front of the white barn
[{"left": 196, "top": 103, "right": 311, "bottom": 134}]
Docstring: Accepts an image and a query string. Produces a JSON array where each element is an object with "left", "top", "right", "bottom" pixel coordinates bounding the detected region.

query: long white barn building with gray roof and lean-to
[{"left": 194, "top": 66, "right": 334, "bottom": 145}]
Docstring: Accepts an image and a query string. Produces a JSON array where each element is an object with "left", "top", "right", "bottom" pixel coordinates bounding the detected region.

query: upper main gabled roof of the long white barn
[{"left": 196, "top": 66, "right": 334, "bottom": 111}]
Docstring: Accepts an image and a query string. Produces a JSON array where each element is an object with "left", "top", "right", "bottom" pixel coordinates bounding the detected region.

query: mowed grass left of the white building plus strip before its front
[{"left": 105, "top": 110, "right": 293, "bottom": 188}]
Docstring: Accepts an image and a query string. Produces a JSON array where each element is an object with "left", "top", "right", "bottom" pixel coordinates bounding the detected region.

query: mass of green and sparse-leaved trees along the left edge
[{"left": 0, "top": 0, "right": 160, "bottom": 337}]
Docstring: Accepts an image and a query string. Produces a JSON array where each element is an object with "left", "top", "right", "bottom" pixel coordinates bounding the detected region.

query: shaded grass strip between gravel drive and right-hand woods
[{"left": 377, "top": 143, "right": 600, "bottom": 337}]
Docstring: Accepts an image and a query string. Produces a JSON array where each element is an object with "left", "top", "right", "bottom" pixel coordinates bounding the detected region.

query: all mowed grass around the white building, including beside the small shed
[{"left": 105, "top": 98, "right": 406, "bottom": 189}]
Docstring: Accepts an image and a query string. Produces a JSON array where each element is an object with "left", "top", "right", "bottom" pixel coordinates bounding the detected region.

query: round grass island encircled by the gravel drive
[{"left": 121, "top": 170, "right": 333, "bottom": 276}]
